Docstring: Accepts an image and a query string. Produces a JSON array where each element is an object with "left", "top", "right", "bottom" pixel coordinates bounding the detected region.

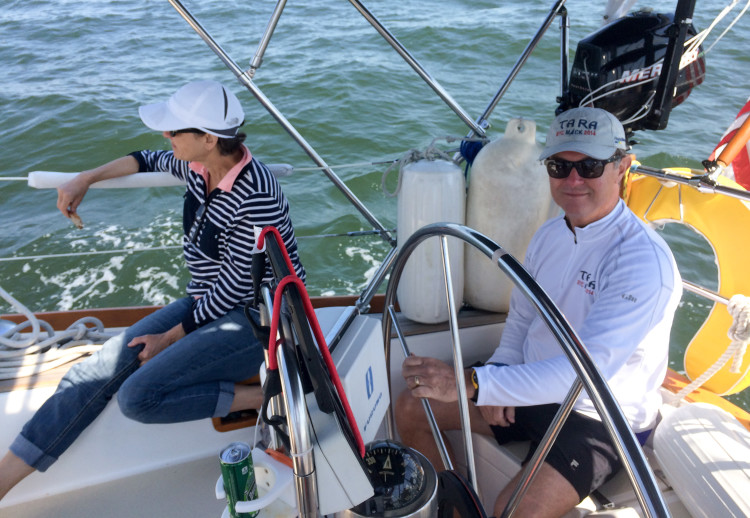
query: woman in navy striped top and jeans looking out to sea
[{"left": 0, "top": 81, "right": 305, "bottom": 498}]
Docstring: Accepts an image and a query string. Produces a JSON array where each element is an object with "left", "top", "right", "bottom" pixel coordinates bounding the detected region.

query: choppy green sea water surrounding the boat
[{"left": 0, "top": 0, "right": 750, "bottom": 406}]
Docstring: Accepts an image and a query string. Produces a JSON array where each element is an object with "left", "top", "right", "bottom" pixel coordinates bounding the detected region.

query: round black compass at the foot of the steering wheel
[{"left": 350, "top": 440, "right": 437, "bottom": 517}]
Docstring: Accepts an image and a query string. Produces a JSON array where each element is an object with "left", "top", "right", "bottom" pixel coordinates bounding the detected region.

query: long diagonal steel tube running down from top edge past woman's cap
[{"left": 168, "top": 0, "right": 396, "bottom": 246}]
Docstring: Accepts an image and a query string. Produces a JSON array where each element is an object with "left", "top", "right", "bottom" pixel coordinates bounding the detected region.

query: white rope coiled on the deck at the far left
[{"left": 0, "top": 288, "right": 114, "bottom": 380}]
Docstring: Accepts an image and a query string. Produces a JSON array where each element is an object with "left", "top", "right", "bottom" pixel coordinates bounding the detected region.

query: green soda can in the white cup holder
[{"left": 219, "top": 442, "right": 259, "bottom": 518}]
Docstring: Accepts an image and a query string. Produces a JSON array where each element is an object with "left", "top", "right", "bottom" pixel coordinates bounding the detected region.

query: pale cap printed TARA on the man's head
[{"left": 539, "top": 107, "right": 628, "bottom": 160}]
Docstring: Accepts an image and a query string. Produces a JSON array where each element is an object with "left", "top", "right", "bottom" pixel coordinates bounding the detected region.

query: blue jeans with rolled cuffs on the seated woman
[{"left": 10, "top": 297, "right": 263, "bottom": 471}]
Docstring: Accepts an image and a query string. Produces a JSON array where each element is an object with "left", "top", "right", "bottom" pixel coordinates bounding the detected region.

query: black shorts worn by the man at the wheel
[{"left": 491, "top": 404, "right": 620, "bottom": 500}]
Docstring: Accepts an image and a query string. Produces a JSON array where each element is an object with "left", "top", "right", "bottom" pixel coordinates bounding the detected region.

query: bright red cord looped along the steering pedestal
[{"left": 258, "top": 227, "right": 365, "bottom": 457}]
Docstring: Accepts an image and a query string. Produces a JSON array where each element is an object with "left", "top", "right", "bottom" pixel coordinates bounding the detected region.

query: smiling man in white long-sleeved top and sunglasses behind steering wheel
[{"left": 396, "top": 108, "right": 682, "bottom": 517}]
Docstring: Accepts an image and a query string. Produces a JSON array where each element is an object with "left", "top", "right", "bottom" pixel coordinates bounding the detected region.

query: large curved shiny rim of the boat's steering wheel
[{"left": 383, "top": 223, "right": 669, "bottom": 517}]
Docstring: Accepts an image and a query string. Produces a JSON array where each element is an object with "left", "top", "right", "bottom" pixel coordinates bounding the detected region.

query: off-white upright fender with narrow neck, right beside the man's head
[{"left": 464, "top": 119, "right": 557, "bottom": 312}]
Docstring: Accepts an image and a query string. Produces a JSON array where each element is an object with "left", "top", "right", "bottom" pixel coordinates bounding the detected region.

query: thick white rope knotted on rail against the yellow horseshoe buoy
[{"left": 669, "top": 295, "right": 750, "bottom": 404}]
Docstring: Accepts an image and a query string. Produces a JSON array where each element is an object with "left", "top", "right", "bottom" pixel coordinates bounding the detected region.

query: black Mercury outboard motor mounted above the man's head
[{"left": 558, "top": 11, "right": 706, "bottom": 131}]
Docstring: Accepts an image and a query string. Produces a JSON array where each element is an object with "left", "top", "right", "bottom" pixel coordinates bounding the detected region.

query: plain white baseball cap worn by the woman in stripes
[{"left": 138, "top": 81, "right": 245, "bottom": 138}]
